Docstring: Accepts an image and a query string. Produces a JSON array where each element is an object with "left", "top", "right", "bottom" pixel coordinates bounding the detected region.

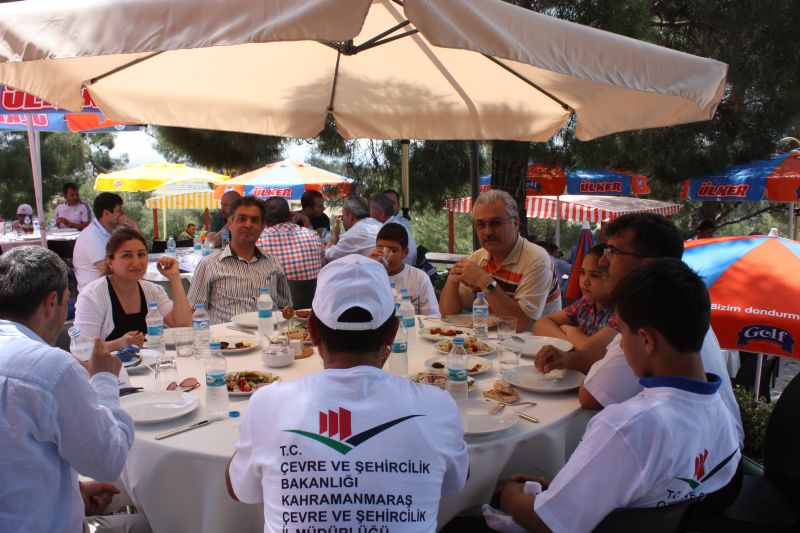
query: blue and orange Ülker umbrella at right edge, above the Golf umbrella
[{"left": 681, "top": 150, "right": 800, "bottom": 202}]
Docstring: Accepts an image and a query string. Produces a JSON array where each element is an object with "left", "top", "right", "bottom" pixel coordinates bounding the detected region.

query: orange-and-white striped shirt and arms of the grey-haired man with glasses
[{"left": 458, "top": 237, "right": 561, "bottom": 320}]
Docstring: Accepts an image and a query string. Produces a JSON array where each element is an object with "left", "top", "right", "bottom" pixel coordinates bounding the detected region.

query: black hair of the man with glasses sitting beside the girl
[{"left": 604, "top": 213, "right": 683, "bottom": 259}]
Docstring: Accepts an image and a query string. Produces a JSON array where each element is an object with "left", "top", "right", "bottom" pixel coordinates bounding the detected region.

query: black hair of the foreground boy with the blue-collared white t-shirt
[{"left": 611, "top": 258, "right": 711, "bottom": 353}]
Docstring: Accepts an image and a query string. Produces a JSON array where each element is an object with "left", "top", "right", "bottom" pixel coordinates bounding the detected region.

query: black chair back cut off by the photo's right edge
[{"left": 764, "top": 368, "right": 800, "bottom": 509}]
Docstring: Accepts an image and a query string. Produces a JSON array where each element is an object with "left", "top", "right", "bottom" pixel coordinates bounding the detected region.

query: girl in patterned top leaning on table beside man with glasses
[{"left": 533, "top": 244, "right": 617, "bottom": 351}]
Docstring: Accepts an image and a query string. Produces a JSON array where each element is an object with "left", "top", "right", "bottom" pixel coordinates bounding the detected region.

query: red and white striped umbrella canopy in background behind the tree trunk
[{"left": 444, "top": 195, "right": 682, "bottom": 222}]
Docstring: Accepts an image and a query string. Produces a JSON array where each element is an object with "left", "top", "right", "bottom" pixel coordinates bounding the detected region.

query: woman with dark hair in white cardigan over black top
[{"left": 75, "top": 224, "right": 192, "bottom": 350}]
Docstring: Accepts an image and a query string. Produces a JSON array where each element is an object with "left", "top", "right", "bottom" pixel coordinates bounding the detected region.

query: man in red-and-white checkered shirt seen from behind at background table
[{"left": 256, "top": 196, "right": 325, "bottom": 281}]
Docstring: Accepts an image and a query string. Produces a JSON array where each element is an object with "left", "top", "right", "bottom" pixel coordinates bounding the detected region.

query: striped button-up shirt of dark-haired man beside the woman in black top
[{"left": 189, "top": 245, "right": 290, "bottom": 324}]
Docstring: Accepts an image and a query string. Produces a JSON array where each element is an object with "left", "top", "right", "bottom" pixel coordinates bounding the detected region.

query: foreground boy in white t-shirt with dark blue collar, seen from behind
[{"left": 501, "top": 259, "right": 740, "bottom": 532}]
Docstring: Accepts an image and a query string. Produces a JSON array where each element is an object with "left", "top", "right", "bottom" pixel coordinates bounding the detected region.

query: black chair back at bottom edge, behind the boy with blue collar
[{"left": 592, "top": 500, "right": 697, "bottom": 533}]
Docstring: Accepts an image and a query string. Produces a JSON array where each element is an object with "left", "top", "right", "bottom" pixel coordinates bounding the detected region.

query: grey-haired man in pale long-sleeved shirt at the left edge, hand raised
[{"left": 0, "top": 246, "right": 134, "bottom": 532}]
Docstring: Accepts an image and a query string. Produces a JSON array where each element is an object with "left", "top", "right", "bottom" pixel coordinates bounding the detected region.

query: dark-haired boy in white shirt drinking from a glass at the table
[{"left": 369, "top": 222, "right": 439, "bottom": 317}]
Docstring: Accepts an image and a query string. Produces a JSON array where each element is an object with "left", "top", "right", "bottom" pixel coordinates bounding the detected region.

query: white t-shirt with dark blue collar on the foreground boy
[{"left": 533, "top": 374, "right": 741, "bottom": 533}]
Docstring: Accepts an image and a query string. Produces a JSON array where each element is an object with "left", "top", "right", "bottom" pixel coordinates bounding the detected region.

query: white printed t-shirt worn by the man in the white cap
[{"left": 230, "top": 366, "right": 469, "bottom": 533}]
